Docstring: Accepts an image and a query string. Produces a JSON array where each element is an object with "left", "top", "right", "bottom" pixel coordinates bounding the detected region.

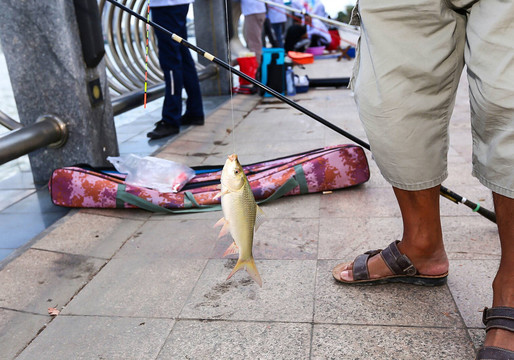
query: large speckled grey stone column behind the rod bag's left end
[{"left": 0, "top": 0, "right": 118, "bottom": 184}]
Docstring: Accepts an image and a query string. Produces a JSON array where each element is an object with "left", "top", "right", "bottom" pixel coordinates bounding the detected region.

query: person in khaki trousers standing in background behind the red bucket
[{"left": 241, "top": 0, "right": 266, "bottom": 65}]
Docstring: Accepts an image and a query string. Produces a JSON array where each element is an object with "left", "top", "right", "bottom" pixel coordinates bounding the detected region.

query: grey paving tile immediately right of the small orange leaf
[{"left": 63, "top": 256, "right": 205, "bottom": 318}]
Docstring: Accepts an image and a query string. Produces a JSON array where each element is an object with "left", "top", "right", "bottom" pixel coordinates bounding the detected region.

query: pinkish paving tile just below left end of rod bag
[{"left": 33, "top": 212, "right": 143, "bottom": 259}]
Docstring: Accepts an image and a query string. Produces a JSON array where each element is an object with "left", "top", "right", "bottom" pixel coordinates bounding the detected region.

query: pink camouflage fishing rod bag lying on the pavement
[{"left": 48, "top": 145, "right": 370, "bottom": 213}]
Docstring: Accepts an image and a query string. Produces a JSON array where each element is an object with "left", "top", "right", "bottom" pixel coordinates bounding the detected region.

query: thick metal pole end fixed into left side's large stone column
[{"left": 0, "top": 115, "right": 68, "bottom": 165}]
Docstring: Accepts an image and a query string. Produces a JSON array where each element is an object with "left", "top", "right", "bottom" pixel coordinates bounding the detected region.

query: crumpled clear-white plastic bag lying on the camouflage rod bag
[{"left": 107, "top": 154, "right": 195, "bottom": 192}]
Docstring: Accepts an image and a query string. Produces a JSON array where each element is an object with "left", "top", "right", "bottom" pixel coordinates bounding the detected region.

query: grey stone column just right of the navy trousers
[{"left": 193, "top": 0, "right": 231, "bottom": 96}]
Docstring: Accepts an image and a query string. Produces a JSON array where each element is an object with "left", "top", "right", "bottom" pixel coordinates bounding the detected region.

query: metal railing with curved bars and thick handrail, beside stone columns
[{"left": 0, "top": 0, "right": 218, "bottom": 165}]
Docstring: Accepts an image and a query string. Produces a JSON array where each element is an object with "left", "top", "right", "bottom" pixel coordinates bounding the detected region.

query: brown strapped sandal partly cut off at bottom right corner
[{"left": 476, "top": 306, "right": 514, "bottom": 360}]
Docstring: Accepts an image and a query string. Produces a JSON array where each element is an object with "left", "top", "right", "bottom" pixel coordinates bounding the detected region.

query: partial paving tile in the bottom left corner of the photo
[{"left": 0, "top": 309, "right": 51, "bottom": 360}]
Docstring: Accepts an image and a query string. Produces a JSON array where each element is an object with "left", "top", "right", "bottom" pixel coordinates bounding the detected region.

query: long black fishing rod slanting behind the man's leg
[{"left": 107, "top": 0, "right": 496, "bottom": 223}]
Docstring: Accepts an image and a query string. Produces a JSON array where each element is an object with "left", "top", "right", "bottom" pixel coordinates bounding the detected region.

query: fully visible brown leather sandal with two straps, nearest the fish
[{"left": 332, "top": 240, "right": 448, "bottom": 286}]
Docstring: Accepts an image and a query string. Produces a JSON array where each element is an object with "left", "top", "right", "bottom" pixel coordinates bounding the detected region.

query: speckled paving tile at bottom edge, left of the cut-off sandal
[{"left": 311, "top": 325, "right": 474, "bottom": 360}]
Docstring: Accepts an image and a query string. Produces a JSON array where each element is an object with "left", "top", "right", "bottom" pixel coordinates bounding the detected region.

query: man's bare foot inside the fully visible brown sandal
[{"left": 334, "top": 242, "right": 449, "bottom": 283}]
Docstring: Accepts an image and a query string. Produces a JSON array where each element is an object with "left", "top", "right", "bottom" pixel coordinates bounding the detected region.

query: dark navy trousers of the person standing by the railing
[{"left": 151, "top": 4, "right": 203, "bottom": 127}]
